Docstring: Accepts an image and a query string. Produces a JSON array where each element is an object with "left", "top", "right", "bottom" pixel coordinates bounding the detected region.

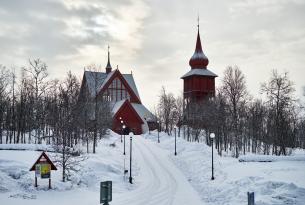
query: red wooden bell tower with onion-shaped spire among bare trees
[{"left": 181, "top": 23, "right": 217, "bottom": 116}]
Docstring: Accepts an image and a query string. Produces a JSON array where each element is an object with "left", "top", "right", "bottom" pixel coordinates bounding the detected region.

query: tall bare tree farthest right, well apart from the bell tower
[{"left": 261, "top": 70, "right": 295, "bottom": 155}]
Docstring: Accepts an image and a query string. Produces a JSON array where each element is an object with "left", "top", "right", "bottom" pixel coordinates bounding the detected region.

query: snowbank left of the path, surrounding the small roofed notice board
[{"left": 0, "top": 132, "right": 138, "bottom": 205}]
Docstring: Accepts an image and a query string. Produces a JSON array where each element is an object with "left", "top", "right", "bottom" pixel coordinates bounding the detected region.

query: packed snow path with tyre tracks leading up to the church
[{"left": 111, "top": 136, "right": 203, "bottom": 205}]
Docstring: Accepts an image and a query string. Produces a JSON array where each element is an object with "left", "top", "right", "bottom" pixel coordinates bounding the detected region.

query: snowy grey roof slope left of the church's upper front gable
[{"left": 85, "top": 71, "right": 107, "bottom": 97}]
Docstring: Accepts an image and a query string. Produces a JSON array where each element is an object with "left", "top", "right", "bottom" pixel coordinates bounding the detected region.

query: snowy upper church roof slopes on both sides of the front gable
[{"left": 85, "top": 70, "right": 140, "bottom": 99}]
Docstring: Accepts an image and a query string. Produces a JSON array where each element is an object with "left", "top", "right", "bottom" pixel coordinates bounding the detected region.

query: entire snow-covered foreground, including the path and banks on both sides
[{"left": 0, "top": 132, "right": 305, "bottom": 205}]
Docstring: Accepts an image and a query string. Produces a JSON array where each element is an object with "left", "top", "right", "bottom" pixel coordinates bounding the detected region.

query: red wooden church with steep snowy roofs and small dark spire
[{"left": 80, "top": 50, "right": 156, "bottom": 134}]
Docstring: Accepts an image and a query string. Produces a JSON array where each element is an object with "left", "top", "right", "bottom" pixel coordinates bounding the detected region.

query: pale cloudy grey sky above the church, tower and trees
[{"left": 0, "top": 0, "right": 305, "bottom": 109}]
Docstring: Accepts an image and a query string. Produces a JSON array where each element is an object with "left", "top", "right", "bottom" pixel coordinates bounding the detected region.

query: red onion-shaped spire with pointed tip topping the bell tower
[{"left": 189, "top": 20, "right": 209, "bottom": 69}]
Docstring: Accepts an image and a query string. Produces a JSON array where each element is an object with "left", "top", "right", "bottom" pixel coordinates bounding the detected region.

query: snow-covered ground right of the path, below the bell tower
[{"left": 145, "top": 133, "right": 305, "bottom": 205}]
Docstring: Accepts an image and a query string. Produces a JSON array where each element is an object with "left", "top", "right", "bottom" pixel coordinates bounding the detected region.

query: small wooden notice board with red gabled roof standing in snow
[{"left": 30, "top": 152, "right": 57, "bottom": 189}]
